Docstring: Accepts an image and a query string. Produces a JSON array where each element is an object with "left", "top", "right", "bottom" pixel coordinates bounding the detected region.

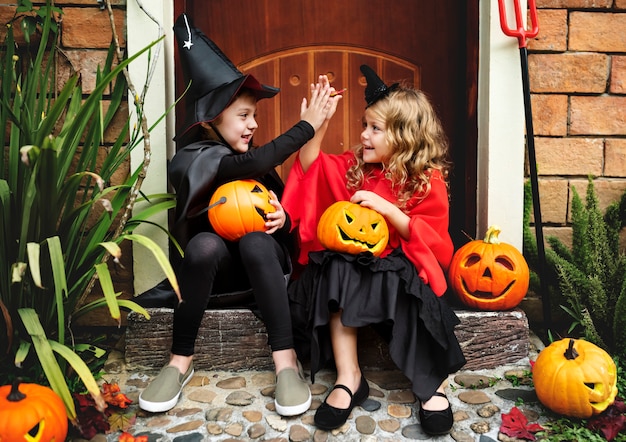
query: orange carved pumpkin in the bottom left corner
[{"left": 0, "top": 380, "right": 67, "bottom": 442}]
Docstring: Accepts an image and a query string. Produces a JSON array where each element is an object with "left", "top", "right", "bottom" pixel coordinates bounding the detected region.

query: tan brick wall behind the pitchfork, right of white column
[{"left": 528, "top": 0, "right": 626, "bottom": 249}]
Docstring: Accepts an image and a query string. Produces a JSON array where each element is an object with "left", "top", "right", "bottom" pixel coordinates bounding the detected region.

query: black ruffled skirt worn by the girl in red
[{"left": 289, "top": 249, "right": 466, "bottom": 401}]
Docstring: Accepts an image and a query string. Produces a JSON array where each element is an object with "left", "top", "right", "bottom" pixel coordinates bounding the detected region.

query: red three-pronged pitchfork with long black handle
[{"left": 498, "top": 0, "right": 551, "bottom": 330}]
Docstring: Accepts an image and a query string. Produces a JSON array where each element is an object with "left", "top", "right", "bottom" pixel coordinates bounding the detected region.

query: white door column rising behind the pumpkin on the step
[{"left": 476, "top": 0, "right": 526, "bottom": 250}]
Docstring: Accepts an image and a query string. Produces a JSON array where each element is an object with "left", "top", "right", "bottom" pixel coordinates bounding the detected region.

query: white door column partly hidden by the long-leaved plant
[{"left": 126, "top": 0, "right": 175, "bottom": 294}]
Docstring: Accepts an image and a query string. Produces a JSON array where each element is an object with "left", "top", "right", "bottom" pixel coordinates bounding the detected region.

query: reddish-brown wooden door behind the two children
[{"left": 175, "top": 0, "right": 478, "bottom": 244}]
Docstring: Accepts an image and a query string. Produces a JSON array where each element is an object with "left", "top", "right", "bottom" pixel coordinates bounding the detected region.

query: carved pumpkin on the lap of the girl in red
[{"left": 317, "top": 201, "right": 389, "bottom": 256}]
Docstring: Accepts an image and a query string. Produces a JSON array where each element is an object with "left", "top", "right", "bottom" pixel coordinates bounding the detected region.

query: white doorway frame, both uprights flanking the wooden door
[{"left": 126, "top": 0, "right": 526, "bottom": 293}]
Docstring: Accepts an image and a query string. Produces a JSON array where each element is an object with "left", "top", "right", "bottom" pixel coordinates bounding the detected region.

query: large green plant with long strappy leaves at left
[{"left": 0, "top": 0, "right": 178, "bottom": 421}]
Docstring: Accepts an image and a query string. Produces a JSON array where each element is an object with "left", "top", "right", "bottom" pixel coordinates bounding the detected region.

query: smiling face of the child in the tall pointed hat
[{"left": 216, "top": 94, "right": 259, "bottom": 153}]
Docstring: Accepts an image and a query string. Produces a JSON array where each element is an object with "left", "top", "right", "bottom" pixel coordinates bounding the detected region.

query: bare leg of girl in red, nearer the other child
[{"left": 326, "top": 312, "right": 362, "bottom": 408}]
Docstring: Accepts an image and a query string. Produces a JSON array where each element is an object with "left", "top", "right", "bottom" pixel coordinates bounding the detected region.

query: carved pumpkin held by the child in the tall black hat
[{"left": 209, "top": 180, "right": 276, "bottom": 241}]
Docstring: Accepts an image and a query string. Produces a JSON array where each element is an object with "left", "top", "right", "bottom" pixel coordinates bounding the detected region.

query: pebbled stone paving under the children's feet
[{"left": 74, "top": 334, "right": 546, "bottom": 442}]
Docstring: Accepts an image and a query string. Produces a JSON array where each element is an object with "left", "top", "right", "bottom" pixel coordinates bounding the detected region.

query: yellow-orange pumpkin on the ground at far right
[{"left": 533, "top": 338, "right": 617, "bottom": 419}]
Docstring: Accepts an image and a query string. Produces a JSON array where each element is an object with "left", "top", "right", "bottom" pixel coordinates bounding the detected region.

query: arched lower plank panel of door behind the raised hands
[{"left": 239, "top": 46, "right": 420, "bottom": 177}]
